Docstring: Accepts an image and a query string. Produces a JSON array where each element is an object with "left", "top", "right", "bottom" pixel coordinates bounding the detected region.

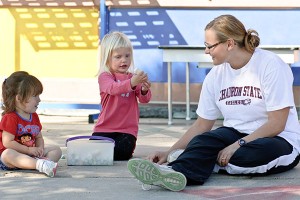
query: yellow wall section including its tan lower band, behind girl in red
[{"left": 0, "top": 8, "right": 100, "bottom": 103}]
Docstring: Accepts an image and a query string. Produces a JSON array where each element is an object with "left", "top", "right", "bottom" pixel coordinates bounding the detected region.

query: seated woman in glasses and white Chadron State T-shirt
[{"left": 128, "top": 15, "right": 300, "bottom": 191}]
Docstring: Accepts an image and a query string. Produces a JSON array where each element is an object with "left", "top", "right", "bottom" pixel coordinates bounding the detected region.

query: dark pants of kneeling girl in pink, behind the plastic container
[{"left": 93, "top": 132, "right": 136, "bottom": 160}]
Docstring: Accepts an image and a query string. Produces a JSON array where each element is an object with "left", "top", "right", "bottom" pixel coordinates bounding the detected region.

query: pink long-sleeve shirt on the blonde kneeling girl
[{"left": 94, "top": 72, "right": 151, "bottom": 137}]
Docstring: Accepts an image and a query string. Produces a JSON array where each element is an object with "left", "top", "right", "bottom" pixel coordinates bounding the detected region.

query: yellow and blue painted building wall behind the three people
[{"left": 0, "top": 7, "right": 300, "bottom": 105}]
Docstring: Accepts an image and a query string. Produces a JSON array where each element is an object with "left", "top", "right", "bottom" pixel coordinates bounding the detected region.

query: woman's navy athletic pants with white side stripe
[{"left": 169, "top": 127, "right": 300, "bottom": 185}]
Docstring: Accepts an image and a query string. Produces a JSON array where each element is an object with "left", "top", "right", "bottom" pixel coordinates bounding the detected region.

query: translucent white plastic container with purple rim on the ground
[{"left": 66, "top": 136, "right": 115, "bottom": 165}]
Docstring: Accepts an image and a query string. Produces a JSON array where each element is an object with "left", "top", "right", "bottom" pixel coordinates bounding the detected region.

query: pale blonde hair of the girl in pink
[{"left": 98, "top": 31, "right": 134, "bottom": 75}]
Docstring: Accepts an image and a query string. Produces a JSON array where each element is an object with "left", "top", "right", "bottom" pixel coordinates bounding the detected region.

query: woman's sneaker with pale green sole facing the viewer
[{"left": 127, "top": 158, "right": 186, "bottom": 191}]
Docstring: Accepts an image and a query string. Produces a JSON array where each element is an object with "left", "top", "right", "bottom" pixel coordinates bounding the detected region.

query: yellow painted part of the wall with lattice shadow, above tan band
[{"left": 0, "top": 8, "right": 98, "bottom": 78}]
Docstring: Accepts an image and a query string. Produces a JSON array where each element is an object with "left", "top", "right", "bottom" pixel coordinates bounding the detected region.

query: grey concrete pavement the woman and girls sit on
[{"left": 0, "top": 115, "right": 300, "bottom": 200}]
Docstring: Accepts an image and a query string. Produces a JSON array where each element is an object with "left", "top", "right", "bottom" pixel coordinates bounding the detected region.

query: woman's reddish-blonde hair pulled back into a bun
[{"left": 205, "top": 15, "right": 260, "bottom": 53}]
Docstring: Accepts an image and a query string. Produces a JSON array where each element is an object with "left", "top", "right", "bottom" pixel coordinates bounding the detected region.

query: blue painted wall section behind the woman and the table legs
[{"left": 108, "top": 8, "right": 300, "bottom": 83}]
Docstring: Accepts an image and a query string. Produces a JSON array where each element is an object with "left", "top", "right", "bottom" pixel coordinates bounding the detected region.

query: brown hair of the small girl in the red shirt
[{"left": 2, "top": 71, "right": 43, "bottom": 115}]
